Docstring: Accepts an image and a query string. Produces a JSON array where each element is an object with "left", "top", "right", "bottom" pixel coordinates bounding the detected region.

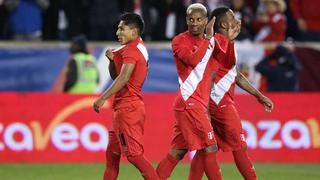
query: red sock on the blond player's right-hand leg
[{"left": 203, "top": 152, "right": 222, "bottom": 180}]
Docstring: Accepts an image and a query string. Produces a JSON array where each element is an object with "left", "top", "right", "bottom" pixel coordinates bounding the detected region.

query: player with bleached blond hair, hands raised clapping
[{"left": 157, "top": 3, "right": 229, "bottom": 180}]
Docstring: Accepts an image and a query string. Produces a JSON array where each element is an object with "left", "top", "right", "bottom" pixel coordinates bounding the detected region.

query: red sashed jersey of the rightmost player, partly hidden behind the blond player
[{"left": 210, "top": 34, "right": 237, "bottom": 105}]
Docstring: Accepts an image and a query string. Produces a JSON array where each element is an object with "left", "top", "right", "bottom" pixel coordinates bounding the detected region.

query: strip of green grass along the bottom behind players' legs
[{"left": 0, "top": 163, "right": 320, "bottom": 180}]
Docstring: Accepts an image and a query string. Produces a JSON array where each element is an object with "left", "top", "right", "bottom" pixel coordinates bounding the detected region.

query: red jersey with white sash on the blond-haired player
[{"left": 172, "top": 32, "right": 226, "bottom": 110}]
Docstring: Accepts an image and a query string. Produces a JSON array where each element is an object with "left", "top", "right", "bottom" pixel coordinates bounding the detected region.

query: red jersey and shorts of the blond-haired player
[{"left": 171, "top": 32, "right": 225, "bottom": 150}]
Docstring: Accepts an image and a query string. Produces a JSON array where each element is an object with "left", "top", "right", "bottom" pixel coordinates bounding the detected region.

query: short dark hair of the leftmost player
[{"left": 120, "top": 13, "right": 144, "bottom": 36}]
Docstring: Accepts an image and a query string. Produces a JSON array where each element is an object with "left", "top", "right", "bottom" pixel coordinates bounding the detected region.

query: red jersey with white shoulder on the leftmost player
[{"left": 113, "top": 38, "right": 148, "bottom": 108}]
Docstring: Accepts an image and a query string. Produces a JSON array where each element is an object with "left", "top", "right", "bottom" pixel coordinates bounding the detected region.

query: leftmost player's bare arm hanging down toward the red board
[{"left": 93, "top": 63, "right": 135, "bottom": 112}]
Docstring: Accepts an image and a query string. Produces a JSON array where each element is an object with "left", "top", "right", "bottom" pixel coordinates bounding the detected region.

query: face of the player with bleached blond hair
[{"left": 186, "top": 9, "right": 208, "bottom": 37}]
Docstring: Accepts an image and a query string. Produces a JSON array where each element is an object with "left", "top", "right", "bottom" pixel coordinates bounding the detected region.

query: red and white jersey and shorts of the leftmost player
[{"left": 108, "top": 39, "right": 148, "bottom": 156}]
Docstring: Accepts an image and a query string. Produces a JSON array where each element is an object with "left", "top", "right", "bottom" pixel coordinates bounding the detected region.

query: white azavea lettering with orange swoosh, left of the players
[{"left": 0, "top": 98, "right": 110, "bottom": 152}]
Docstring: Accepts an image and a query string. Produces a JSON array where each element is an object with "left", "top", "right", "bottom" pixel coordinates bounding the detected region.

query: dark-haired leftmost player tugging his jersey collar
[{"left": 93, "top": 13, "right": 159, "bottom": 180}]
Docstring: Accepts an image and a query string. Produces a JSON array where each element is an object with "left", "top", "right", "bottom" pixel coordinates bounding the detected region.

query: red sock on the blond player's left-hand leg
[{"left": 157, "top": 154, "right": 179, "bottom": 180}]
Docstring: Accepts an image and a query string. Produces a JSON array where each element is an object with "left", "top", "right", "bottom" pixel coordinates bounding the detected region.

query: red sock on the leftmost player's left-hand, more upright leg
[{"left": 103, "top": 151, "right": 120, "bottom": 180}]
